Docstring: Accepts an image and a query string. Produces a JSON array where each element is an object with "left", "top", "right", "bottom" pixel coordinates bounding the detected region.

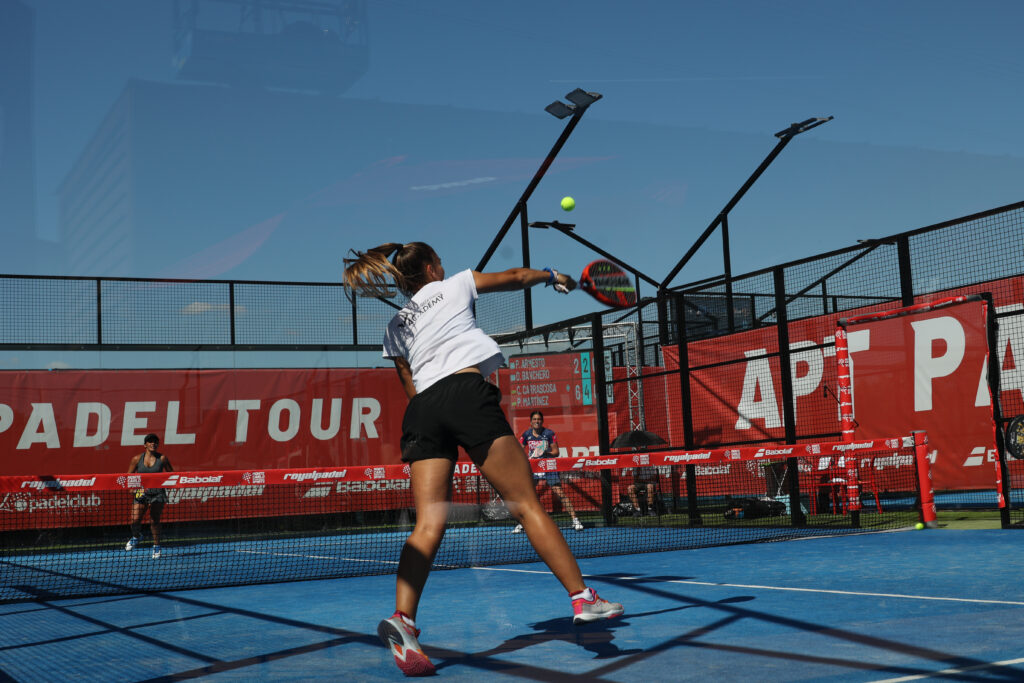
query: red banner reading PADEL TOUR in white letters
[{"left": 0, "top": 369, "right": 408, "bottom": 474}]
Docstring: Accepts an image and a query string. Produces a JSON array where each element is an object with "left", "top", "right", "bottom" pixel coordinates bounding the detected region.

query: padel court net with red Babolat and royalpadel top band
[{"left": 0, "top": 433, "right": 934, "bottom": 602}]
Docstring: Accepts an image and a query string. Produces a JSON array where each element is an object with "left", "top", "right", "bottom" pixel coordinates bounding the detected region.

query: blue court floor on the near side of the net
[{"left": 0, "top": 530, "right": 1024, "bottom": 682}]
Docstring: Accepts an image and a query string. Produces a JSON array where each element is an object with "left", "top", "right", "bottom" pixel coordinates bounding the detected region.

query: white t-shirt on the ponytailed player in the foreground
[{"left": 384, "top": 270, "right": 505, "bottom": 392}]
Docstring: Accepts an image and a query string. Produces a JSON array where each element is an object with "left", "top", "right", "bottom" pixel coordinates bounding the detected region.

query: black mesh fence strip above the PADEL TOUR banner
[{"left": 0, "top": 275, "right": 525, "bottom": 350}]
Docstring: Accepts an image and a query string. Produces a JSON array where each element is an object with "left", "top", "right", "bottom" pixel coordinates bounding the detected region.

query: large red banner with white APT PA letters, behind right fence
[{"left": 647, "top": 278, "right": 1024, "bottom": 489}]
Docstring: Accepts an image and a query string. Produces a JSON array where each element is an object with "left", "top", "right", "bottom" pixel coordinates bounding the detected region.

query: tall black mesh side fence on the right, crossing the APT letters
[{"left": 630, "top": 204, "right": 1024, "bottom": 516}]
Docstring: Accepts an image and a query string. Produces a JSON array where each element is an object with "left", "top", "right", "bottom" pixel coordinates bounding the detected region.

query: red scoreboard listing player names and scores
[{"left": 508, "top": 351, "right": 594, "bottom": 410}]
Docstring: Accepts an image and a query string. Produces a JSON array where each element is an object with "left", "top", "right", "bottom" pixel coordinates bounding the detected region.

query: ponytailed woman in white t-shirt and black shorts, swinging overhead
[{"left": 345, "top": 242, "right": 623, "bottom": 676}]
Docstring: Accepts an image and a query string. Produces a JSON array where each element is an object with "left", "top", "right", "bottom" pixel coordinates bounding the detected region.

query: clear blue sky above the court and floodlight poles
[{"left": 0, "top": 0, "right": 1024, "bottom": 331}]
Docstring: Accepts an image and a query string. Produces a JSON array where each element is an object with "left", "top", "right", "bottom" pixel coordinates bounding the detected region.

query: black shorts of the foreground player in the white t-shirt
[{"left": 401, "top": 373, "right": 514, "bottom": 465}]
